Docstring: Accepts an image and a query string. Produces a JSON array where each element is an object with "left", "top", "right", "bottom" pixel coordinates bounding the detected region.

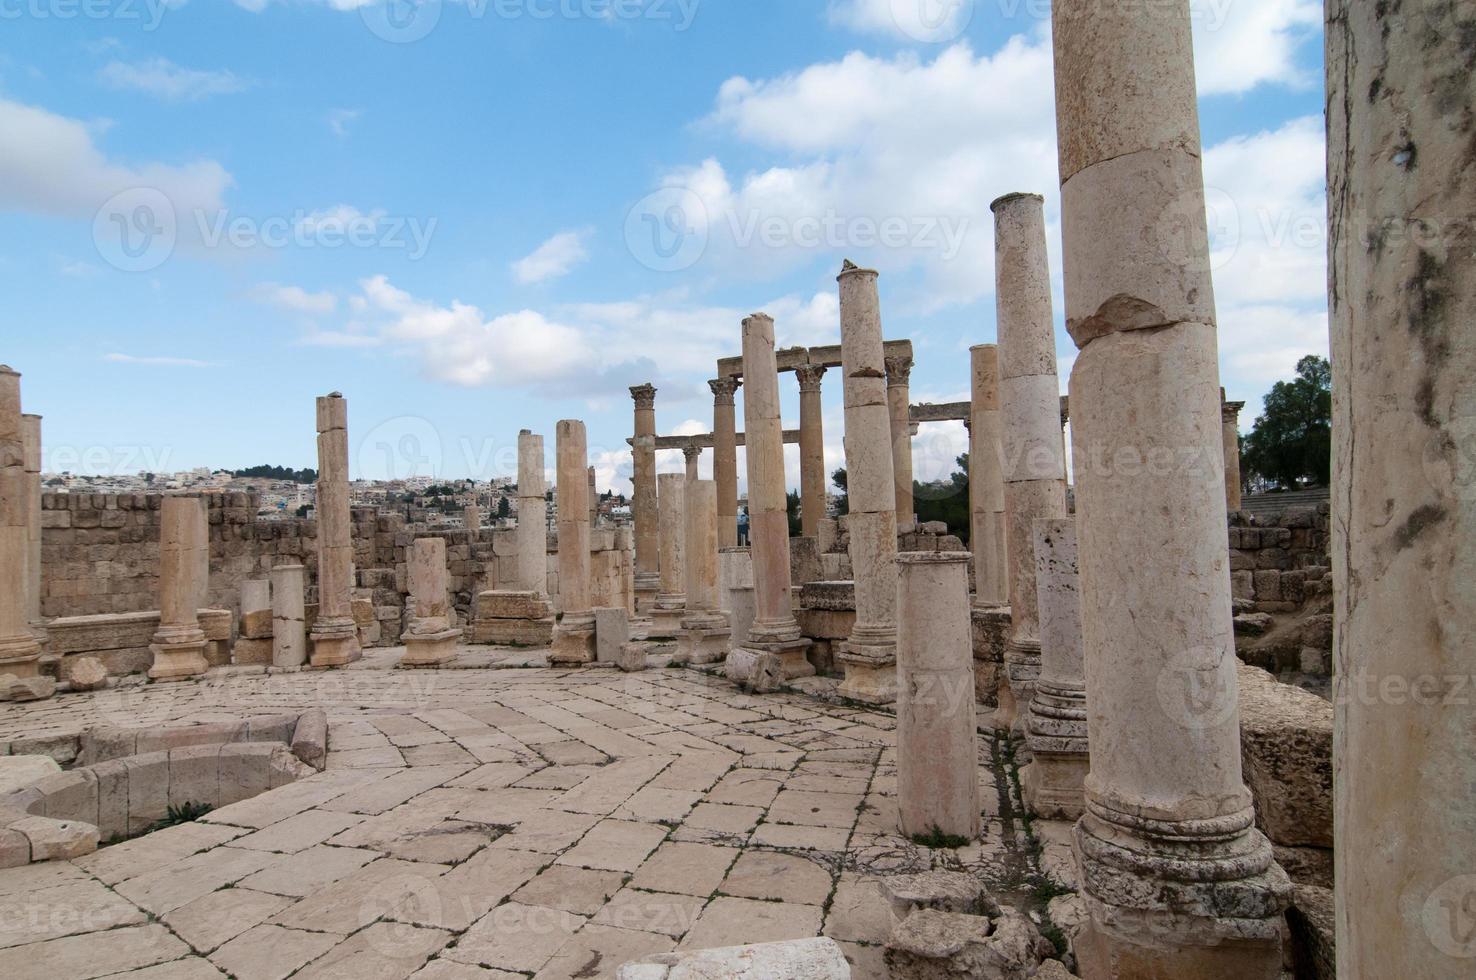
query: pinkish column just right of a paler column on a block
[{"left": 549, "top": 419, "right": 595, "bottom": 666}]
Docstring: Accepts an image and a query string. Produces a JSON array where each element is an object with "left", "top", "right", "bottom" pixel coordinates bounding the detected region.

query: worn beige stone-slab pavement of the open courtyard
[{"left": 0, "top": 648, "right": 1069, "bottom": 980}]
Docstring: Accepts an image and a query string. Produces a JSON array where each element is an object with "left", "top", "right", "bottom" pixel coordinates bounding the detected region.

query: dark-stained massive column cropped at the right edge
[{"left": 1327, "top": 0, "right": 1476, "bottom": 977}]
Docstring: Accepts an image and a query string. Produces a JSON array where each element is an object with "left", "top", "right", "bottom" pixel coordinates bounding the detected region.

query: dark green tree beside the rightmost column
[{"left": 1240, "top": 354, "right": 1333, "bottom": 490}]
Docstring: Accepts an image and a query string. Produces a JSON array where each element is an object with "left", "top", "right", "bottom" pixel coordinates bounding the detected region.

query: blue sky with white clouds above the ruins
[{"left": 0, "top": 0, "right": 1327, "bottom": 490}]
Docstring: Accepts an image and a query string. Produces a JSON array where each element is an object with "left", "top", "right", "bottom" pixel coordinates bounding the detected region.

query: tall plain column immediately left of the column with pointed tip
[{"left": 742, "top": 313, "right": 815, "bottom": 679}]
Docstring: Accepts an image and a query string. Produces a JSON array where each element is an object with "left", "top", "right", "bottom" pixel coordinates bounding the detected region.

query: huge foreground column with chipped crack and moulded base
[{"left": 1056, "top": 0, "right": 1287, "bottom": 980}]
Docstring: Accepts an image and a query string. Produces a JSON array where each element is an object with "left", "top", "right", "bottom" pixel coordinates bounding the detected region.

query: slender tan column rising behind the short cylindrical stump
[{"left": 968, "top": 344, "right": 1010, "bottom": 610}]
